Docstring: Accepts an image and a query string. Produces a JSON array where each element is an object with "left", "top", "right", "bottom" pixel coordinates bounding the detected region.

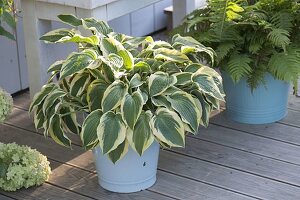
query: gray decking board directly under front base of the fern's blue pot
[{"left": 210, "top": 111, "right": 300, "bottom": 146}]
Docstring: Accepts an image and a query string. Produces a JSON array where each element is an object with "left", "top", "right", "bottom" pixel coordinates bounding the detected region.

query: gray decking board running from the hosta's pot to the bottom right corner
[{"left": 159, "top": 152, "right": 300, "bottom": 200}]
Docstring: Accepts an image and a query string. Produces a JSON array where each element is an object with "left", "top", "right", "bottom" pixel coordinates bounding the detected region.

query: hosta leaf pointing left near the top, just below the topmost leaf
[{"left": 40, "top": 28, "right": 75, "bottom": 43}]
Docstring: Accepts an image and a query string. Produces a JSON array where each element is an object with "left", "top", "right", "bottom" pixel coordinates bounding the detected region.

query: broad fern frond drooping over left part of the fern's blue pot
[{"left": 226, "top": 53, "right": 252, "bottom": 82}]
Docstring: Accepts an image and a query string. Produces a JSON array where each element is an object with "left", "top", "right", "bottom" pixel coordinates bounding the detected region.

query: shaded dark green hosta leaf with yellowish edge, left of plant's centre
[{"left": 87, "top": 79, "right": 109, "bottom": 111}]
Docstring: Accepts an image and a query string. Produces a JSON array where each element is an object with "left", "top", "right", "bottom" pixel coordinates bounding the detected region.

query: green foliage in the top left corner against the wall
[{"left": 0, "top": 0, "right": 16, "bottom": 40}]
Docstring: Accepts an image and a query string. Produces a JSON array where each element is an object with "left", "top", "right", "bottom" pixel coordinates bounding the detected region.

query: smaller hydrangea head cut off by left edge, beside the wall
[{"left": 0, "top": 88, "right": 13, "bottom": 123}]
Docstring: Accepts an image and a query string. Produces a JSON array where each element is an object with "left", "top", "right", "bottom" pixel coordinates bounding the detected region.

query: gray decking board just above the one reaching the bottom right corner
[{"left": 172, "top": 137, "right": 300, "bottom": 186}]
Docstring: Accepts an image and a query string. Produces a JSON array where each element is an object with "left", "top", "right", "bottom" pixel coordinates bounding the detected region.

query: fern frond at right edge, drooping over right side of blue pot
[{"left": 268, "top": 48, "right": 300, "bottom": 82}]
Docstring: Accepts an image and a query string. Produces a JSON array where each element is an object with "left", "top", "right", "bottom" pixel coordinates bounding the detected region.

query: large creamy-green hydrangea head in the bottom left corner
[{"left": 0, "top": 142, "right": 51, "bottom": 191}]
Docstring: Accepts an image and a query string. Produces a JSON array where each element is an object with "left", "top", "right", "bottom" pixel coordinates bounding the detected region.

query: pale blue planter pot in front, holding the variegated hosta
[{"left": 93, "top": 142, "right": 159, "bottom": 193}]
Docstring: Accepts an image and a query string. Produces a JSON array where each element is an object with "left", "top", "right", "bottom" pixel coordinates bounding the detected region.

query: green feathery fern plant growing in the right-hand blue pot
[{"left": 175, "top": 0, "right": 300, "bottom": 90}]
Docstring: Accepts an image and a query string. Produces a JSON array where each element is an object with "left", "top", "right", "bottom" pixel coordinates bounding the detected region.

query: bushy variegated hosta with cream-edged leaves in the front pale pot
[{"left": 30, "top": 15, "right": 224, "bottom": 162}]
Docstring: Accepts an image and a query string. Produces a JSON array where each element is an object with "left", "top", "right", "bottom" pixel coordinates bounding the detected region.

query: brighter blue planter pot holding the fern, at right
[{"left": 222, "top": 72, "right": 290, "bottom": 124}]
